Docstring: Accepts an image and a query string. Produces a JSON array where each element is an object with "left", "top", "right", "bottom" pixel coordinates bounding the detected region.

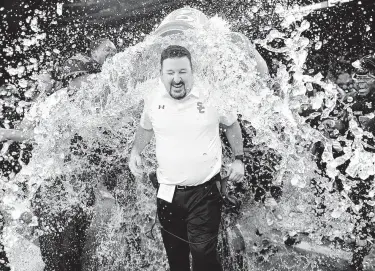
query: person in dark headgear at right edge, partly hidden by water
[{"left": 346, "top": 55, "right": 375, "bottom": 271}]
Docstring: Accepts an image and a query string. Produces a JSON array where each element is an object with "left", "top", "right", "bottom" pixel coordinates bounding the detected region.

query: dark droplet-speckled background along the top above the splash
[{"left": 0, "top": 0, "right": 375, "bottom": 84}]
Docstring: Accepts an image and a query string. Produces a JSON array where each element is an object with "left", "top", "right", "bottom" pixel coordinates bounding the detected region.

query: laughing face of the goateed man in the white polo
[{"left": 161, "top": 57, "right": 194, "bottom": 100}]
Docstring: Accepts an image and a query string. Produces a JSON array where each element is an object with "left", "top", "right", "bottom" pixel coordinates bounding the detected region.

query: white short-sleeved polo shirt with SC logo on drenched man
[{"left": 140, "top": 81, "right": 237, "bottom": 186}]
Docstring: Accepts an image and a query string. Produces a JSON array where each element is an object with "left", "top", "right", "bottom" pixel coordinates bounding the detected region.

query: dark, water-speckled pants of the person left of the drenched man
[{"left": 32, "top": 173, "right": 95, "bottom": 271}]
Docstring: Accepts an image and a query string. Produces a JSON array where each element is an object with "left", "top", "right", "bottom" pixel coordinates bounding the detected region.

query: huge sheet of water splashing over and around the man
[{"left": 1, "top": 3, "right": 375, "bottom": 270}]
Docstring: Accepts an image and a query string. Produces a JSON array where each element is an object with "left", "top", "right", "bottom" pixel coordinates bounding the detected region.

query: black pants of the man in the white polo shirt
[{"left": 157, "top": 175, "right": 222, "bottom": 271}]
